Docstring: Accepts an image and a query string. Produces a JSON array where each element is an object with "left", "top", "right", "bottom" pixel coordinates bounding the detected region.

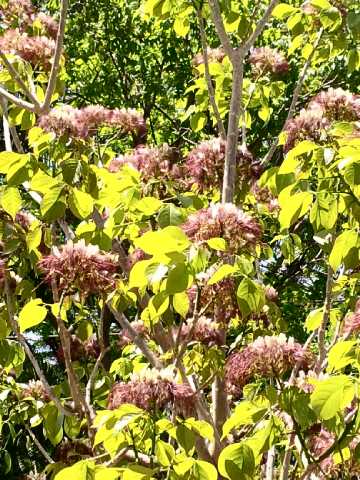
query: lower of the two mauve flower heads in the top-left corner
[{"left": 0, "top": 29, "right": 55, "bottom": 70}]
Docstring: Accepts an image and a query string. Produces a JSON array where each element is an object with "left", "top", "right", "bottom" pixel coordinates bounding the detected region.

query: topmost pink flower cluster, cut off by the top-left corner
[{"left": 0, "top": 0, "right": 58, "bottom": 38}]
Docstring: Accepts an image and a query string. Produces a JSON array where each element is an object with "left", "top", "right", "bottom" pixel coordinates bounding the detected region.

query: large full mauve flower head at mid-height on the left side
[{"left": 38, "top": 240, "right": 117, "bottom": 296}]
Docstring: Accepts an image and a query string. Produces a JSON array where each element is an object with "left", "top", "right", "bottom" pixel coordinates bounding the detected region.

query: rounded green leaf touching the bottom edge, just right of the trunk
[{"left": 218, "top": 443, "right": 255, "bottom": 480}]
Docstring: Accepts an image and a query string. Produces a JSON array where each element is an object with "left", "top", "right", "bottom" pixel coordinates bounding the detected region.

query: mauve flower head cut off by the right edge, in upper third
[{"left": 309, "top": 88, "right": 360, "bottom": 122}]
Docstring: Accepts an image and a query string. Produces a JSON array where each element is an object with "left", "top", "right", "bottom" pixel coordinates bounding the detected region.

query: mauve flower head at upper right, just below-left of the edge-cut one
[{"left": 284, "top": 108, "right": 330, "bottom": 153}]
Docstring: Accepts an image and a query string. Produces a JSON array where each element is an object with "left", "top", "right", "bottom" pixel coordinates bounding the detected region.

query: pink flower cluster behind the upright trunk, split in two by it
[{"left": 185, "top": 138, "right": 261, "bottom": 191}]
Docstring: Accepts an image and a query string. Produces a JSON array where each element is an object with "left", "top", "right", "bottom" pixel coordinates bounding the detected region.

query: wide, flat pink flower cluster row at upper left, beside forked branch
[{"left": 39, "top": 105, "right": 146, "bottom": 139}]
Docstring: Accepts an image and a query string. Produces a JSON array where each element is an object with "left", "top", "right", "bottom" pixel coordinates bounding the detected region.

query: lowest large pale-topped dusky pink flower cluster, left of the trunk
[{"left": 108, "top": 369, "right": 195, "bottom": 415}]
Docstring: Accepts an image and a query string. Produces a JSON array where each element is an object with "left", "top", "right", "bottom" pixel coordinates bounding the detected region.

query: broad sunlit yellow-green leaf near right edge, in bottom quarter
[{"left": 310, "top": 375, "right": 355, "bottom": 420}]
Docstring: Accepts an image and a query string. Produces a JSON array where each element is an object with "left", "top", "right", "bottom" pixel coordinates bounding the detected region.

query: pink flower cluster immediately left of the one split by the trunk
[{"left": 109, "top": 145, "right": 180, "bottom": 182}]
